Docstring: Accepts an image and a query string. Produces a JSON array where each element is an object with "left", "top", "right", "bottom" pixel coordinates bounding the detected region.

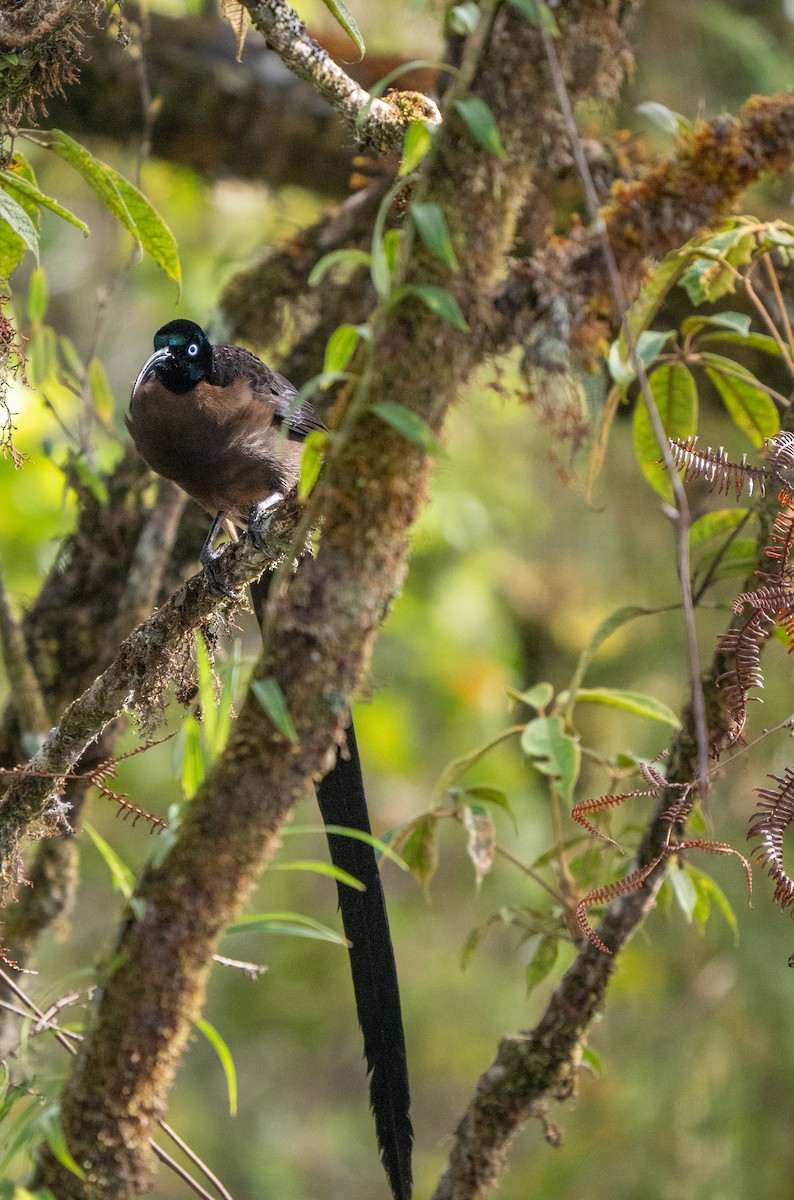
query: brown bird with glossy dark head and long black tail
[{"left": 127, "top": 318, "right": 414, "bottom": 1200}]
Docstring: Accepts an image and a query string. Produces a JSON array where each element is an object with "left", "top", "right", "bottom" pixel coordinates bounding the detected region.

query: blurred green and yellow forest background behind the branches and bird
[{"left": 0, "top": 0, "right": 794, "bottom": 1200}]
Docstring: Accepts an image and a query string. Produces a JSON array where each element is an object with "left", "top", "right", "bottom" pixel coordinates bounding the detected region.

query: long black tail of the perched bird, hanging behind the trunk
[{"left": 251, "top": 571, "right": 414, "bottom": 1200}]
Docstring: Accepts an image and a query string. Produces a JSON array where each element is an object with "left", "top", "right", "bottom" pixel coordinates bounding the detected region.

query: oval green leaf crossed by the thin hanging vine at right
[{"left": 633, "top": 362, "right": 698, "bottom": 500}]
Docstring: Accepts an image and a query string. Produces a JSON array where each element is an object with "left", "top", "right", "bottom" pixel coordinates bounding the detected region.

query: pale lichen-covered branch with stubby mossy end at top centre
[{"left": 246, "top": 0, "right": 440, "bottom": 154}]
